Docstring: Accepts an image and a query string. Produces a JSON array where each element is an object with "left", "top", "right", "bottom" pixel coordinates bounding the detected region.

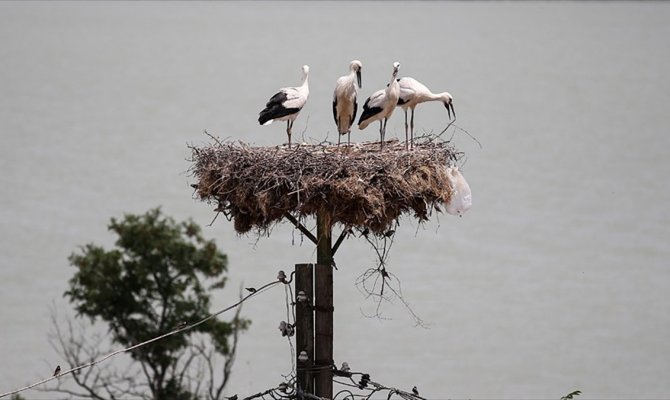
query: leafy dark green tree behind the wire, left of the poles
[{"left": 51, "top": 208, "right": 249, "bottom": 399}]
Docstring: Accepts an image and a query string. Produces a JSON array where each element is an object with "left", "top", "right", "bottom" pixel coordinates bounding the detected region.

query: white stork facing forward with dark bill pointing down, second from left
[{"left": 333, "top": 60, "right": 363, "bottom": 146}]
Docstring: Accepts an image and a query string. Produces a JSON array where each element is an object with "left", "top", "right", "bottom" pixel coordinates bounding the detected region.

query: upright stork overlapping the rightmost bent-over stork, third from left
[{"left": 358, "top": 62, "right": 400, "bottom": 149}]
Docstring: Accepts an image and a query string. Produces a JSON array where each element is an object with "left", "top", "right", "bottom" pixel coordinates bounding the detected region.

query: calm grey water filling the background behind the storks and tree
[{"left": 0, "top": 2, "right": 670, "bottom": 399}]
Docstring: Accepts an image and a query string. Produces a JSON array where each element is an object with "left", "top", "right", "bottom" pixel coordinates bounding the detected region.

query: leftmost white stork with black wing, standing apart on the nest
[{"left": 258, "top": 65, "right": 309, "bottom": 149}]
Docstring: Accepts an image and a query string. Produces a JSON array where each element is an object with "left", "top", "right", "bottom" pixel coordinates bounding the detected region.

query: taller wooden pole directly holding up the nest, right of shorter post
[{"left": 314, "top": 210, "right": 334, "bottom": 399}]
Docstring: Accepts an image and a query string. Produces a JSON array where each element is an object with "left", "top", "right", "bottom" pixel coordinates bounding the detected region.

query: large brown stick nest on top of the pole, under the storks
[{"left": 190, "top": 137, "right": 462, "bottom": 234}]
